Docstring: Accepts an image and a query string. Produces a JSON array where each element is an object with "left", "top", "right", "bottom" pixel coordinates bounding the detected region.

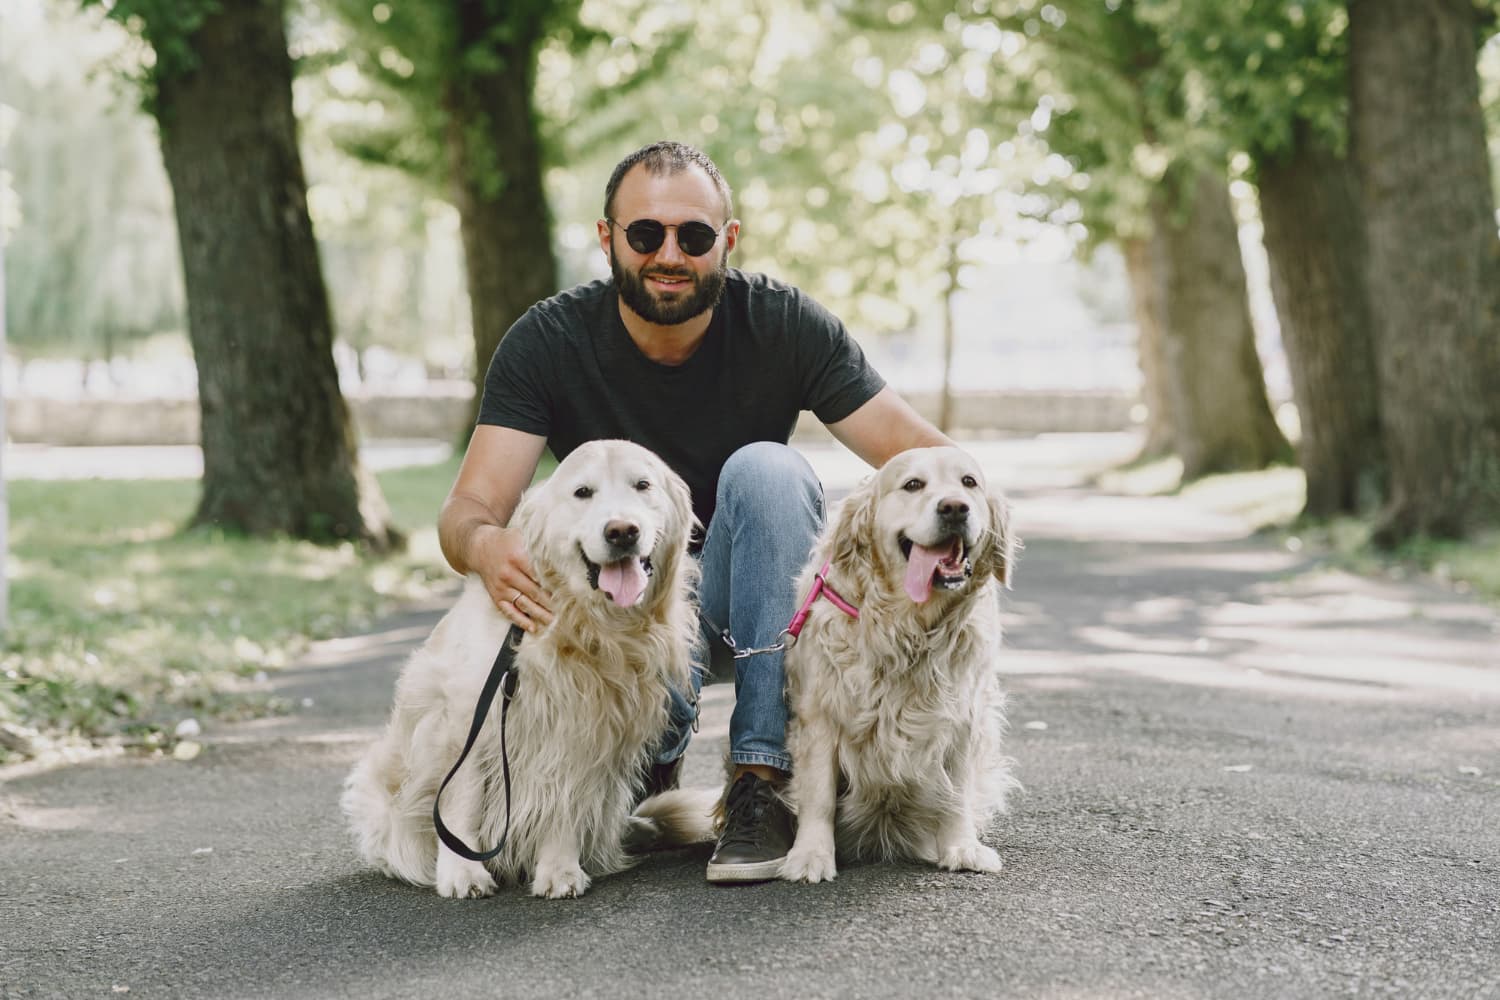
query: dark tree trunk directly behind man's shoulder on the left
[{"left": 447, "top": 0, "right": 558, "bottom": 434}]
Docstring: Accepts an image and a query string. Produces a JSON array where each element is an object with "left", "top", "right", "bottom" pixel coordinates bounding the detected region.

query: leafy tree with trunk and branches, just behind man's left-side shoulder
[{"left": 332, "top": 0, "right": 681, "bottom": 425}]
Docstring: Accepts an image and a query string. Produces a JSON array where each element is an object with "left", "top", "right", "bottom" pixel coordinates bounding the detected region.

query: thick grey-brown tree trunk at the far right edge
[{"left": 1350, "top": 0, "right": 1500, "bottom": 544}]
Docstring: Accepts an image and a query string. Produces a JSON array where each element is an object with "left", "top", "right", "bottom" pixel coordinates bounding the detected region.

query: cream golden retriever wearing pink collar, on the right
[{"left": 782, "top": 448, "right": 1016, "bottom": 882}]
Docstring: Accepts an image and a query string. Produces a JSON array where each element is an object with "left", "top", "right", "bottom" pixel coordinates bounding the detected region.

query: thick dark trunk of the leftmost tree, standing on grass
[{"left": 147, "top": 0, "right": 401, "bottom": 549}]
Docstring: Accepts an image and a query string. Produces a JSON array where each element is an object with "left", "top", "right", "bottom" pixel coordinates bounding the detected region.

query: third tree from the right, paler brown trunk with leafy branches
[{"left": 996, "top": 0, "right": 1292, "bottom": 478}]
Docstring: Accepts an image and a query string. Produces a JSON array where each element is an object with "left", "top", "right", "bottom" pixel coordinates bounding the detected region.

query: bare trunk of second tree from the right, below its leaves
[{"left": 1257, "top": 124, "right": 1386, "bottom": 519}]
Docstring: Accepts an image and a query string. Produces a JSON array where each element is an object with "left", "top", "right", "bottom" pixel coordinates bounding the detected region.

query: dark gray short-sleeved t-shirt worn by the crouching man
[{"left": 479, "top": 268, "right": 885, "bottom": 526}]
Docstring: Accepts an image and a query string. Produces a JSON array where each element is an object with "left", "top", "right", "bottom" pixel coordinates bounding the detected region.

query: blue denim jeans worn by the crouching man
[{"left": 657, "top": 441, "right": 824, "bottom": 771}]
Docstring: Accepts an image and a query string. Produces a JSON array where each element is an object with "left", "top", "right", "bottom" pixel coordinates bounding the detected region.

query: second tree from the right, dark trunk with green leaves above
[{"left": 1143, "top": 0, "right": 1385, "bottom": 517}]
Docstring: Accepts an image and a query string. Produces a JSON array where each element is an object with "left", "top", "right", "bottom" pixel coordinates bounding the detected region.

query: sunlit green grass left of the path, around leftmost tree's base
[{"left": 0, "top": 459, "right": 458, "bottom": 762}]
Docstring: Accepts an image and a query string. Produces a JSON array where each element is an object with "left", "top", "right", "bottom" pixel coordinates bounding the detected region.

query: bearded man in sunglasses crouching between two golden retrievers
[{"left": 438, "top": 142, "right": 951, "bottom": 882}]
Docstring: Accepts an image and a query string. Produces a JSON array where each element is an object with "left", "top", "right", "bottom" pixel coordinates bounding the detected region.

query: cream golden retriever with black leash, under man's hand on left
[{"left": 342, "top": 441, "right": 698, "bottom": 898}]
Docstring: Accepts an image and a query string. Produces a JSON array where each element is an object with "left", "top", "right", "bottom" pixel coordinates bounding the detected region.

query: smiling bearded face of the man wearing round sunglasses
[{"left": 599, "top": 166, "right": 740, "bottom": 327}]
